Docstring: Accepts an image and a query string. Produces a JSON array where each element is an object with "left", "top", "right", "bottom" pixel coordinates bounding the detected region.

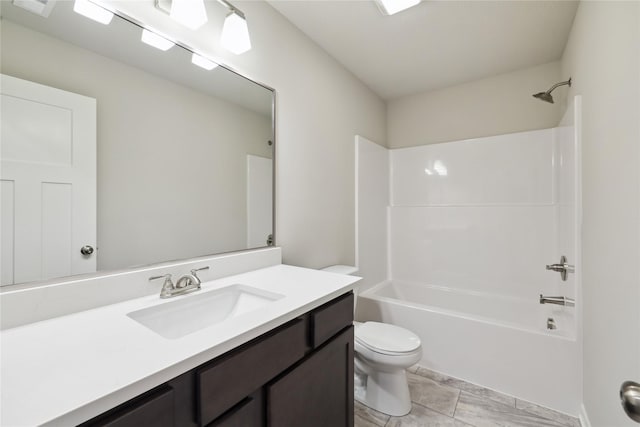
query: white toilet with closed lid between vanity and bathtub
[{"left": 322, "top": 265, "right": 422, "bottom": 416}]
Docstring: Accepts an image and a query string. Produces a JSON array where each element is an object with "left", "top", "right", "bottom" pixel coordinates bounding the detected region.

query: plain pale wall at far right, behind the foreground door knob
[{"left": 562, "top": 1, "right": 640, "bottom": 427}]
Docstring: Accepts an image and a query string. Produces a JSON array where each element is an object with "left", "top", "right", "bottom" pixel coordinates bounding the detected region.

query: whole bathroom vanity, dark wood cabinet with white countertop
[{"left": 1, "top": 256, "right": 358, "bottom": 427}]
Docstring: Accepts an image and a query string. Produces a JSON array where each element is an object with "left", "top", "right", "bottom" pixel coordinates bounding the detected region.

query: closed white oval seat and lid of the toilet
[{"left": 355, "top": 322, "right": 421, "bottom": 356}]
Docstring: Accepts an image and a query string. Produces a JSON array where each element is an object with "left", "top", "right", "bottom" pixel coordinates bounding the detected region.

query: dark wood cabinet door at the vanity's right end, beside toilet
[{"left": 267, "top": 326, "right": 353, "bottom": 427}]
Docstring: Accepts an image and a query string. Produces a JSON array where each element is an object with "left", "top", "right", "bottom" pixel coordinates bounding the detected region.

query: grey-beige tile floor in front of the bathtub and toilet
[{"left": 355, "top": 366, "right": 580, "bottom": 427}]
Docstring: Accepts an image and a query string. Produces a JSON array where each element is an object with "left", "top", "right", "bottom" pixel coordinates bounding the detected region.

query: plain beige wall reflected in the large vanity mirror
[{"left": 0, "top": 2, "right": 273, "bottom": 284}]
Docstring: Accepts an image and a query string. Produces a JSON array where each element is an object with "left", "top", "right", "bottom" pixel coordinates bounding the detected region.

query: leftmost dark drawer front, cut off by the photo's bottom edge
[{"left": 80, "top": 385, "right": 174, "bottom": 427}]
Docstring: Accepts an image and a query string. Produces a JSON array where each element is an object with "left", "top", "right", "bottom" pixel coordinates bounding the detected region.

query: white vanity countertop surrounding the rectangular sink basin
[{"left": 0, "top": 265, "right": 359, "bottom": 427}]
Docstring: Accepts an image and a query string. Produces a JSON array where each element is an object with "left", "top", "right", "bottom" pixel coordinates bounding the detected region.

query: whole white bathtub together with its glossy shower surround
[{"left": 357, "top": 119, "right": 581, "bottom": 416}]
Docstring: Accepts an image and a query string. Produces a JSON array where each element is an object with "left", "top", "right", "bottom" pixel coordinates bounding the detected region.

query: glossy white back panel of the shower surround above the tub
[{"left": 389, "top": 129, "right": 575, "bottom": 337}]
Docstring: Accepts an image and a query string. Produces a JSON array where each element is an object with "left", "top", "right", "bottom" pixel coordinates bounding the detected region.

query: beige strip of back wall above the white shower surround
[{"left": 387, "top": 62, "right": 568, "bottom": 148}]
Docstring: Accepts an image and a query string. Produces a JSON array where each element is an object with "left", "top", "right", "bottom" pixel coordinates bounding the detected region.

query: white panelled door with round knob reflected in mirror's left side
[{"left": 0, "top": 75, "right": 96, "bottom": 285}]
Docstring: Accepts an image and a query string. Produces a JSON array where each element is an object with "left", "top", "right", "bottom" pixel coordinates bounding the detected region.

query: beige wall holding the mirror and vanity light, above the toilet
[{"left": 96, "top": 0, "right": 386, "bottom": 267}]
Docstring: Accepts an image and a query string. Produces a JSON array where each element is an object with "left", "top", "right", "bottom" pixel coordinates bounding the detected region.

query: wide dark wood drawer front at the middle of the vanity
[{"left": 196, "top": 319, "right": 306, "bottom": 425}]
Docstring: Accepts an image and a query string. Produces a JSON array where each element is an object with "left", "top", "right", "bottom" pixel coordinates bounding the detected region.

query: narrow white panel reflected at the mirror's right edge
[{"left": 247, "top": 154, "right": 273, "bottom": 248}]
